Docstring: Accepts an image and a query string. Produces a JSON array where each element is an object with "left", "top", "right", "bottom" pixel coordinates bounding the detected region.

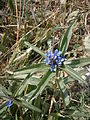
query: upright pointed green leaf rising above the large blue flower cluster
[{"left": 59, "top": 21, "right": 75, "bottom": 55}]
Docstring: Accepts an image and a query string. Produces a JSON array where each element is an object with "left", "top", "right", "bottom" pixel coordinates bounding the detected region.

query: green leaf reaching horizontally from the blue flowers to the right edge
[{"left": 67, "top": 57, "right": 90, "bottom": 68}]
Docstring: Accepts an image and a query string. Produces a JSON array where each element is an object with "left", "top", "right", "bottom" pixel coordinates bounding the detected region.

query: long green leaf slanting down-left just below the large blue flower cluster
[{"left": 30, "top": 71, "right": 55, "bottom": 100}]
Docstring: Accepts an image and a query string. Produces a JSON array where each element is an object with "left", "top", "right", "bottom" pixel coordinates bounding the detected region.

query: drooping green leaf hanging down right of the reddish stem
[{"left": 57, "top": 78, "right": 70, "bottom": 107}]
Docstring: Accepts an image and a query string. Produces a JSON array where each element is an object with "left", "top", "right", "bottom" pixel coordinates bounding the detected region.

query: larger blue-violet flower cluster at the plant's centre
[{"left": 44, "top": 49, "right": 65, "bottom": 72}]
